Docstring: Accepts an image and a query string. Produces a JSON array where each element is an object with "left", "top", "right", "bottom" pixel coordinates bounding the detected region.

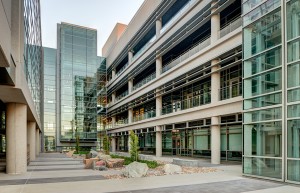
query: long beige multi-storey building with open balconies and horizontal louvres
[{"left": 102, "top": 0, "right": 243, "bottom": 164}]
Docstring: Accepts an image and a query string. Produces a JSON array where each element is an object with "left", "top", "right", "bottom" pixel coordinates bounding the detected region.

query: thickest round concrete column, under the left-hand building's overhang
[{"left": 6, "top": 103, "right": 27, "bottom": 174}]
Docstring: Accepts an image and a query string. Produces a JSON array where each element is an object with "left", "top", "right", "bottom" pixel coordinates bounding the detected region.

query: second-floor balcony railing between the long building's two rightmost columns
[{"left": 162, "top": 92, "right": 211, "bottom": 115}]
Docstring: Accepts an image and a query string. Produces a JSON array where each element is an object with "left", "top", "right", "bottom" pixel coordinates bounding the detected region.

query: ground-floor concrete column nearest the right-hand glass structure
[{"left": 210, "top": 117, "right": 221, "bottom": 164}]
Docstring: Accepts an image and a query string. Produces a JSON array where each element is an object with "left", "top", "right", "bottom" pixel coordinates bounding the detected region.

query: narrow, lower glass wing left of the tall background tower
[{"left": 43, "top": 48, "right": 56, "bottom": 152}]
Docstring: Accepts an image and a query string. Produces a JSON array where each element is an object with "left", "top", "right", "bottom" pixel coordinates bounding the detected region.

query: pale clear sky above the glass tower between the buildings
[{"left": 41, "top": 0, "right": 144, "bottom": 56}]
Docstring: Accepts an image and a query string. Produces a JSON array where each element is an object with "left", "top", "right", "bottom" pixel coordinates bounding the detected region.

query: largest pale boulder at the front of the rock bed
[{"left": 123, "top": 162, "right": 149, "bottom": 178}]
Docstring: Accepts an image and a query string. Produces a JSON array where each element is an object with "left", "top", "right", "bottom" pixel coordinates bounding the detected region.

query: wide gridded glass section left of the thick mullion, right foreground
[{"left": 243, "top": 0, "right": 283, "bottom": 179}]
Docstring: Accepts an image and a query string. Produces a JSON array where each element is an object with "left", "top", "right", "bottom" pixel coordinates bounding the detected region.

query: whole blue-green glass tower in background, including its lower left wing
[{"left": 44, "top": 23, "right": 103, "bottom": 151}]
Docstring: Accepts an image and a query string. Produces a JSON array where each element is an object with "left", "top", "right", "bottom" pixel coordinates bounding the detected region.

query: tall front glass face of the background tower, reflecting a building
[{"left": 59, "top": 23, "right": 99, "bottom": 141}]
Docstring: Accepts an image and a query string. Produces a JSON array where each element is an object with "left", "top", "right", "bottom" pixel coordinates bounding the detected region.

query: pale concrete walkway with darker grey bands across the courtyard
[{"left": 0, "top": 154, "right": 300, "bottom": 193}]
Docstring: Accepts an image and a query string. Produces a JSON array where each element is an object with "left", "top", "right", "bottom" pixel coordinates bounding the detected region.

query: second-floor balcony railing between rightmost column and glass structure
[{"left": 219, "top": 82, "right": 243, "bottom": 100}]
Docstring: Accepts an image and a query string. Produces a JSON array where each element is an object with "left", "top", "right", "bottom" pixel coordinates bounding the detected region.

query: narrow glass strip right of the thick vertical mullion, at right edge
[{"left": 286, "top": 0, "right": 300, "bottom": 183}]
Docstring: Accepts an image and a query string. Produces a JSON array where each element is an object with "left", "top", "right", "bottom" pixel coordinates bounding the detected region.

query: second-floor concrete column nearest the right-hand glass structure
[{"left": 211, "top": 60, "right": 221, "bottom": 103}]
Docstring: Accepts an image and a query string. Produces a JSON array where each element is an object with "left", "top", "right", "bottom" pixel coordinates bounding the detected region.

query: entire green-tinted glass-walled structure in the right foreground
[{"left": 242, "top": 0, "right": 300, "bottom": 183}]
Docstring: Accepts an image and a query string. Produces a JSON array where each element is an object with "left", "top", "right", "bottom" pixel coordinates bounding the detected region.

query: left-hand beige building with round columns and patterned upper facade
[{"left": 0, "top": 0, "right": 43, "bottom": 174}]
